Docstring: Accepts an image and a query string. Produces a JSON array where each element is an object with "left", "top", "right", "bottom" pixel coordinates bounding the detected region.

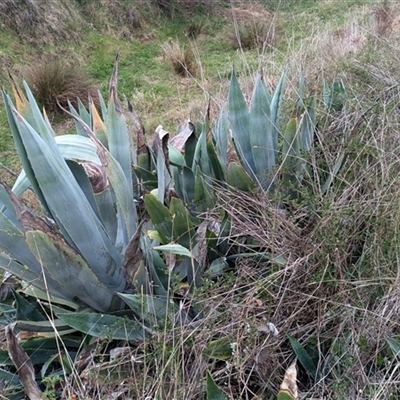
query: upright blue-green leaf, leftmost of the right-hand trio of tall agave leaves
[{"left": 228, "top": 71, "right": 256, "bottom": 180}]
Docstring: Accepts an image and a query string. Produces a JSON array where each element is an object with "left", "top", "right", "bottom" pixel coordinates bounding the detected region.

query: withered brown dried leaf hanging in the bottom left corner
[{"left": 5, "top": 324, "right": 42, "bottom": 400}]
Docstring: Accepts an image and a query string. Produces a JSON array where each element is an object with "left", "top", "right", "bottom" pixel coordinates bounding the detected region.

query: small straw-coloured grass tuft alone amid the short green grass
[{"left": 162, "top": 40, "right": 197, "bottom": 77}]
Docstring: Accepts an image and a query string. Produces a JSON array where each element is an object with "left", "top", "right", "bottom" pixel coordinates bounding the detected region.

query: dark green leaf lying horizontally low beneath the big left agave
[{"left": 57, "top": 312, "right": 148, "bottom": 340}]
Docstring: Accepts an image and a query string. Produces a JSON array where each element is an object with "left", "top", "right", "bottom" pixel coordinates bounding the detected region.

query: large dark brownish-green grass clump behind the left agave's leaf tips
[{"left": 24, "top": 56, "right": 99, "bottom": 114}]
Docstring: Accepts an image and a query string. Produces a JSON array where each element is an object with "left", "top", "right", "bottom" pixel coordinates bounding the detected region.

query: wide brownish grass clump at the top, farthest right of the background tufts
[{"left": 228, "top": 19, "right": 281, "bottom": 50}]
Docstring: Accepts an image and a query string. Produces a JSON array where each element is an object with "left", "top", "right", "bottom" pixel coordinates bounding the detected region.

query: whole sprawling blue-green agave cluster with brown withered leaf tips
[{"left": 0, "top": 52, "right": 350, "bottom": 396}]
